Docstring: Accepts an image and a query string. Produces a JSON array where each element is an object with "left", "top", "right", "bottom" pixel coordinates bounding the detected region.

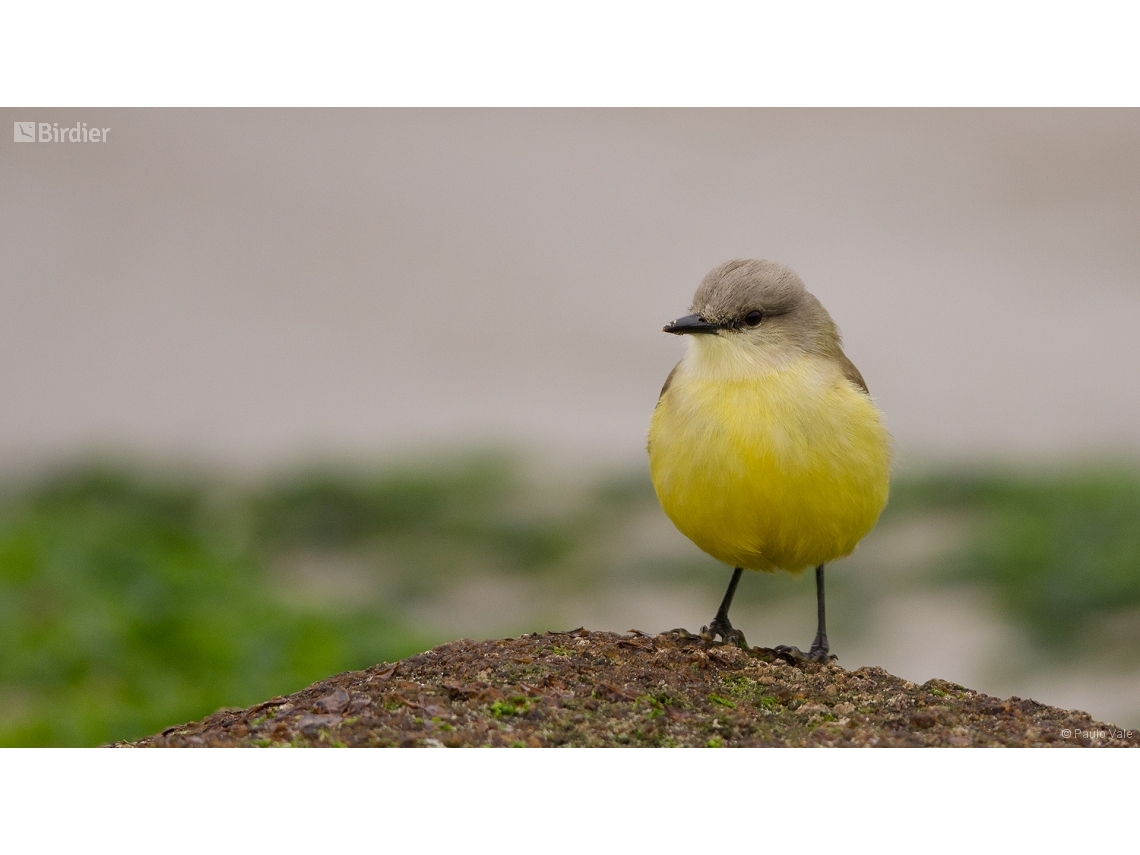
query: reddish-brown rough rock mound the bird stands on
[{"left": 119, "top": 629, "right": 1140, "bottom": 747}]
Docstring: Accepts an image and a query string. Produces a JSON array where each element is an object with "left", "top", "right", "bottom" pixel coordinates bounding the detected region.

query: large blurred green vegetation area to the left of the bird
[{"left": 0, "top": 455, "right": 651, "bottom": 746}]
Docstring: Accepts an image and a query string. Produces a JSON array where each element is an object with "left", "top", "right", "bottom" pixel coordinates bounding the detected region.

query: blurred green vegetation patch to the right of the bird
[{"left": 890, "top": 467, "right": 1140, "bottom": 654}]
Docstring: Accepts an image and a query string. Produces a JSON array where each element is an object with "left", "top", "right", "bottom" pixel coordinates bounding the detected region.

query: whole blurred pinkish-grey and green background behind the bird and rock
[{"left": 0, "top": 109, "right": 1140, "bottom": 744}]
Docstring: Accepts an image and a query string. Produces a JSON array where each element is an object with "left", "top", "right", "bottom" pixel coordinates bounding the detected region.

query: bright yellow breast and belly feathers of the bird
[{"left": 650, "top": 359, "right": 890, "bottom": 572}]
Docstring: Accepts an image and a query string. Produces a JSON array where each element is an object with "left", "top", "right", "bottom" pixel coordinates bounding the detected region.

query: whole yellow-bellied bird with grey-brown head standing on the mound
[{"left": 646, "top": 259, "right": 893, "bottom": 662}]
